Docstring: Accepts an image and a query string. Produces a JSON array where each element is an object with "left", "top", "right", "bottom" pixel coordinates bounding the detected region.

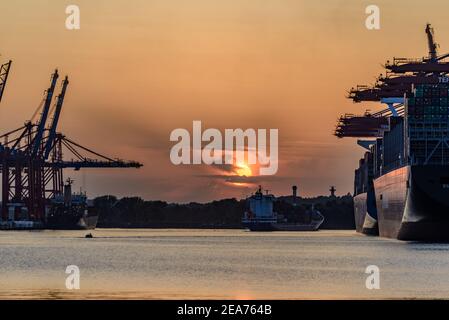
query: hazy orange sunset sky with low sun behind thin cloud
[{"left": 0, "top": 0, "right": 449, "bottom": 202}]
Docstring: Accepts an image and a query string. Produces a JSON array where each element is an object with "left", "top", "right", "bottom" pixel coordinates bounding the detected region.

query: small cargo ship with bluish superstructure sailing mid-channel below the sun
[{"left": 242, "top": 186, "right": 324, "bottom": 231}]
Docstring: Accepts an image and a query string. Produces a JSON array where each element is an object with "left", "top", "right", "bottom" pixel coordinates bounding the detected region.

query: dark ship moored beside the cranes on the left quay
[{"left": 45, "top": 178, "right": 98, "bottom": 230}]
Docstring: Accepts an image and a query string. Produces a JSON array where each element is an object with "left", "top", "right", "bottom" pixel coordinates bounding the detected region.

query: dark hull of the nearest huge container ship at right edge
[{"left": 374, "top": 165, "right": 449, "bottom": 241}]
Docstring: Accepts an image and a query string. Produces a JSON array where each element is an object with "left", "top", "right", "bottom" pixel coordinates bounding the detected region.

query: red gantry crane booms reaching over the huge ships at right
[{"left": 334, "top": 24, "right": 449, "bottom": 139}]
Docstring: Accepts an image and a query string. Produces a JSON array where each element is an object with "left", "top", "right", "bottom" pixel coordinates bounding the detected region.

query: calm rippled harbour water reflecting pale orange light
[{"left": 0, "top": 229, "right": 449, "bottom": 299}]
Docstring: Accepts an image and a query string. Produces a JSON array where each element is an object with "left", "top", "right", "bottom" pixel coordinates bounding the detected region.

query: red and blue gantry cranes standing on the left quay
[{"left": 0, "top": 61, "right": 142, "bottom": 225}]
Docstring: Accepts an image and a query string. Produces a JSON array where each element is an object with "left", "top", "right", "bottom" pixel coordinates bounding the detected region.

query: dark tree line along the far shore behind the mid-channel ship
[{"left": 94, "top": 195, "right": 355, "bottom": 230}]
